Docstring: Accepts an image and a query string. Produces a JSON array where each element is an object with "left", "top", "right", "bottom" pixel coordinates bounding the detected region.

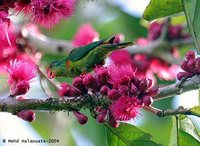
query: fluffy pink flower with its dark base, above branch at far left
[{"left": 8, "top": 60, "right": 37, "bottom": 96}]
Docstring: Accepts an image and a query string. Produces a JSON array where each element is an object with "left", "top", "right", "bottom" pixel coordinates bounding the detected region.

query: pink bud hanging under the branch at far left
[{"left": 16, "top": 110, "right": 35, "bottom": 122}]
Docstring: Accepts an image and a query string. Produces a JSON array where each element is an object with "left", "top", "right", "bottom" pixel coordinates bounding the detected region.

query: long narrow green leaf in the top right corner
[{"left": 182, "top": 0, "right": 200, "bottom": 53}]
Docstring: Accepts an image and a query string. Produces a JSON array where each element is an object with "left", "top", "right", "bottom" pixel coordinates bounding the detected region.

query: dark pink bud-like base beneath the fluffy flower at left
[{"left": 10, "top": 80, "right": 30, "bottom": 96}]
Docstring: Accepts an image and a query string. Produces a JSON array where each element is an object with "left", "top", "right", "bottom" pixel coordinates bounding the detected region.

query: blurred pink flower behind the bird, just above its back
[{"left": 72, "top": 24, "right": 99, "bottom": 47}]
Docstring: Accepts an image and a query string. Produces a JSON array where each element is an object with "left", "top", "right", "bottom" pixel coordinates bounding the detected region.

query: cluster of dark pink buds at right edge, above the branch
[{"left": 177, "top": 51, "right": 200, "bottom": 80}]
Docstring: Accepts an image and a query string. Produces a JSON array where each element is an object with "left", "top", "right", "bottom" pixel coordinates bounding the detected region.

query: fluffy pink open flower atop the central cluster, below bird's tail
[{"left": 108, "top": 64, "right": 135, "bottom": 86}]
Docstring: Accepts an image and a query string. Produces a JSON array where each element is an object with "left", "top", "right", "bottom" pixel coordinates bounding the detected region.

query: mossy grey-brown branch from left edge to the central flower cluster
[{"left": 0, "top": 94, "right": 109, "bottom": 114}]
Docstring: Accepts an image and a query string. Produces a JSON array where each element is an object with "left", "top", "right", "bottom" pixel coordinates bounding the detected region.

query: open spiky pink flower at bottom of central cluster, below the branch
[{"left": 109, "top": 96, "right": 141, "bottom": 121}]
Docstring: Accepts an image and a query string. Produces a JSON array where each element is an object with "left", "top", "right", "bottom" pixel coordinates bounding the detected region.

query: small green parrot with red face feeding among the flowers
[{"left": 47, "top": 36, "right": 133, "bottom": 78}]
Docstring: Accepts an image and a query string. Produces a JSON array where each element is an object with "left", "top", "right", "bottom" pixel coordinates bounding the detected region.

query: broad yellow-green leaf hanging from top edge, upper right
[{"left": 143, "top": 0, "right": 183, "bottom": 21}]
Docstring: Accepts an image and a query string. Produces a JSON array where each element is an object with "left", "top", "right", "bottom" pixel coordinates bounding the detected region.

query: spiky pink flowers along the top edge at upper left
[{"left": 0, "top": 0, "right": 76, "bottom": 28}]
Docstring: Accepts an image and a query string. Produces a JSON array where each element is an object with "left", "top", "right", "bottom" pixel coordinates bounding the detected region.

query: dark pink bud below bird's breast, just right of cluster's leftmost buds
[{"left": 72, "top": 77, "right": 87, "bottom": 93}]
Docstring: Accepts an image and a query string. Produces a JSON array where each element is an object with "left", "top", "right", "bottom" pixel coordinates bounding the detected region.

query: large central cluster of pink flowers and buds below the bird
[{"left": 59, "top": 65, "right": 158, "bottom": 127}]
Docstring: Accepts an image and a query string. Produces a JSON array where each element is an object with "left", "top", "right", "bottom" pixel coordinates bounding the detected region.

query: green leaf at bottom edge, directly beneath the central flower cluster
[{"left": 106, "top": 123, "right": 159, "bottom": 146}]
